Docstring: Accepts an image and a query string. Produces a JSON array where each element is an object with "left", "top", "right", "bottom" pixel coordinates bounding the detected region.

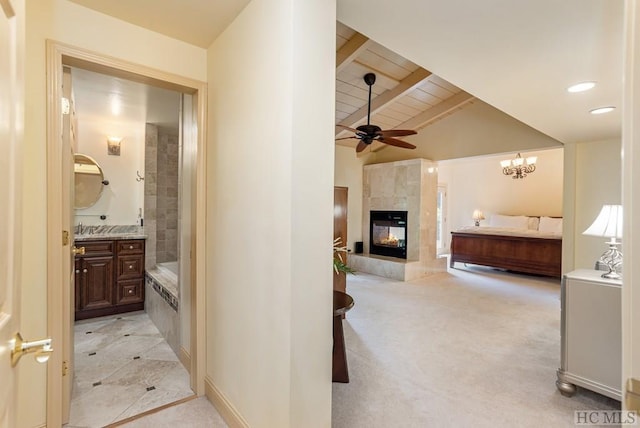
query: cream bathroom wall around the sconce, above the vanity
[{"left": 75, "top": 118, "right": 145, "bottom": 225}]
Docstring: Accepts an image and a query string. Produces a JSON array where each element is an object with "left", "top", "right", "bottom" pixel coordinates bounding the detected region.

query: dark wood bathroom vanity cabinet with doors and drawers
[{"left": 75, "top": 239, "right": 145, "bottom": 320}]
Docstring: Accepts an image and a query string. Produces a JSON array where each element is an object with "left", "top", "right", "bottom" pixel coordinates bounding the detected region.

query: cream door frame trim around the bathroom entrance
[{"left": 47, "top": 42, "right": 206, "bottom": 426}]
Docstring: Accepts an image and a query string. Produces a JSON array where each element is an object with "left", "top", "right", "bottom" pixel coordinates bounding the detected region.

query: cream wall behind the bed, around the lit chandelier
[{"left": 438, "top": 149, "right": 563, "bottom": 247}]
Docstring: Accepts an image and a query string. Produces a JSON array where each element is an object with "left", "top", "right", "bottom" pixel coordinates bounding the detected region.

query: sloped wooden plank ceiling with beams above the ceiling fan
[{"left": 335, "top": 22, "right": 474, "bottom": 153}]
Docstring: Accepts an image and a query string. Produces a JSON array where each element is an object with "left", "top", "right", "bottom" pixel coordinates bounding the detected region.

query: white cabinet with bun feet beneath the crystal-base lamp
[{"left": 556, "top": 269, "right": 622, "bottom": 400}]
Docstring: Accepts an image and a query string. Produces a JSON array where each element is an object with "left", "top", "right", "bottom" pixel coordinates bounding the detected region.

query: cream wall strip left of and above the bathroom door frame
[{"left": 18, "top": 0, "right": 207, "bottom": 426}]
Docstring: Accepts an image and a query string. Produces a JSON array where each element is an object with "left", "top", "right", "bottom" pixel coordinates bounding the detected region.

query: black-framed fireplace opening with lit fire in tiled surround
[{"left": 369, "top": 211, "right": 407, "bottom": 259}]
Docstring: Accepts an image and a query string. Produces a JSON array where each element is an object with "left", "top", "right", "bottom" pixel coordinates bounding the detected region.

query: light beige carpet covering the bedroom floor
[{"left": 332, "top": 267, "right": 620, "bottom": 428}]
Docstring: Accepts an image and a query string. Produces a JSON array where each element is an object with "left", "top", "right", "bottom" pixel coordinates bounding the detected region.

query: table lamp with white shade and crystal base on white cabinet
[{"left": 582, "top": 205, "right": 622, "bottom": 279}]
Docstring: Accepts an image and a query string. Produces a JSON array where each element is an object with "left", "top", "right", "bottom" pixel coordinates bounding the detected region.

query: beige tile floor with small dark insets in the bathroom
[{"left": 65, "top": 312, "right": 193, "bottom": 428}]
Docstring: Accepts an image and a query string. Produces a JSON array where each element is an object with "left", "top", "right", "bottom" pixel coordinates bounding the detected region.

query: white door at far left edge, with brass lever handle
[{"left": 0, "top": 0, "right": 24, "bottom": 428}]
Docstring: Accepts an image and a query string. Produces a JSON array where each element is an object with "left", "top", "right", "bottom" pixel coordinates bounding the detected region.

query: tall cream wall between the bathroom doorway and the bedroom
[{"left": 206, "top": 0, "right": 335, "bottom": 427}]
